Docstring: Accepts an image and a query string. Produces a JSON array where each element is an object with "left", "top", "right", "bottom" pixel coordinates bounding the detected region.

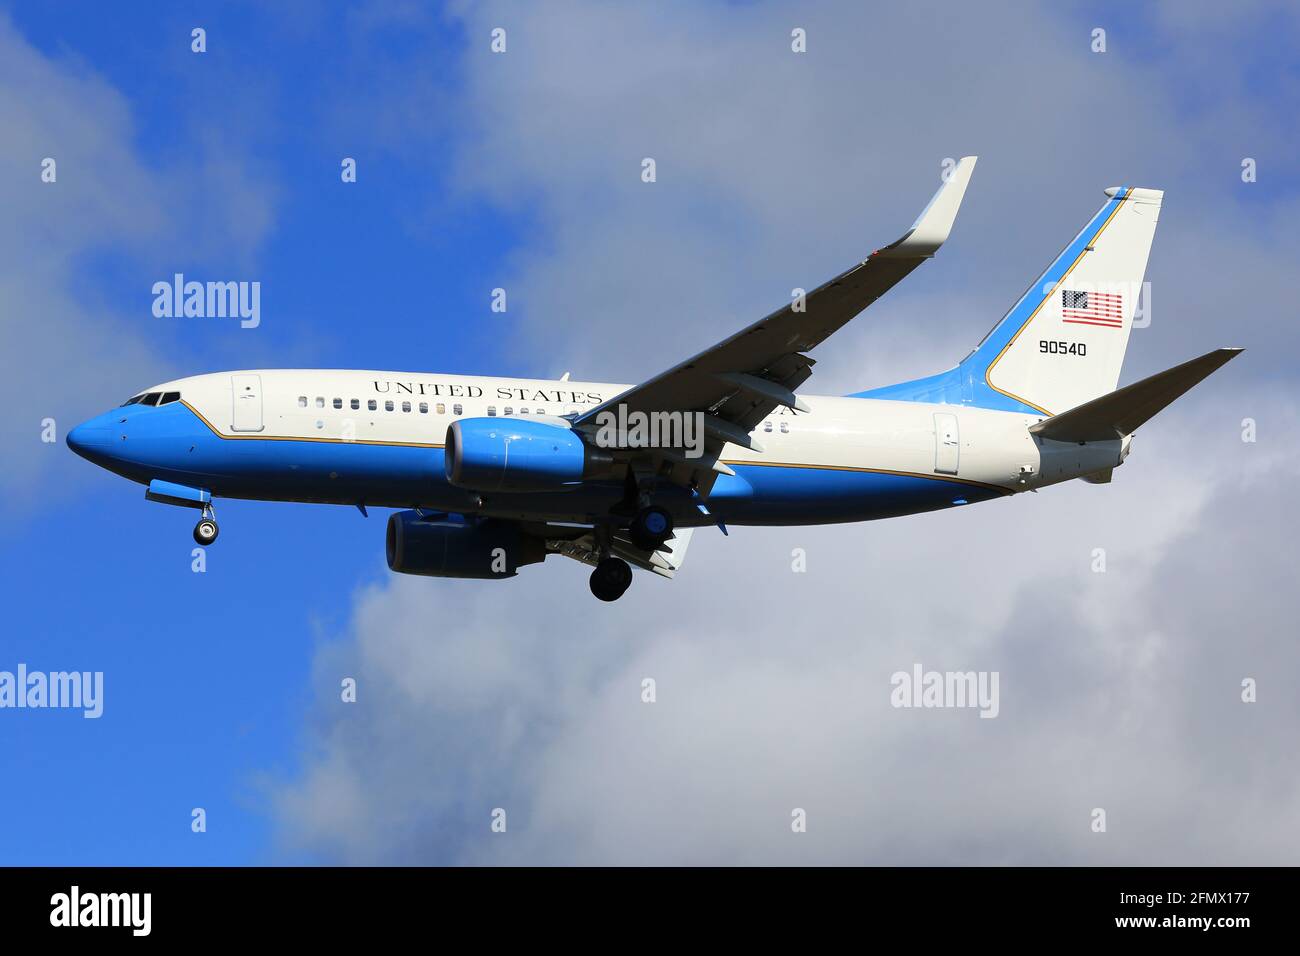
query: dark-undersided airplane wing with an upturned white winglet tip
[{"left": 573, "top": 156, "right": 976, "bottom": 493}]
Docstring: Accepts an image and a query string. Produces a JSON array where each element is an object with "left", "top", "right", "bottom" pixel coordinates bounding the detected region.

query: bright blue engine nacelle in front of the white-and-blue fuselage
[{"left": 443, "top": 418, "right": 614, "bottom": 492}]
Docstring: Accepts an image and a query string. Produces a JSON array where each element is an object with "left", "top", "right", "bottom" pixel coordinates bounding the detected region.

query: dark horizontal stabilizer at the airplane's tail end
[{"left": 1030, "top": 349, "right": 1242, "bottom": 442}]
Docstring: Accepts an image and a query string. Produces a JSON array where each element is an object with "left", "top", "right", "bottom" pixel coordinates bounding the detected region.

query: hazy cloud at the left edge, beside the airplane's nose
[{"left": 0, "top": 16, "right": 270, "bottom": 515}]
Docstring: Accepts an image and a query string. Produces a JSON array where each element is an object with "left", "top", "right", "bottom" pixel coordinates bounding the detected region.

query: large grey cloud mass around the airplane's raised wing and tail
[{"left": 268, "top": 4, "right": 1300, "bottom": 864}]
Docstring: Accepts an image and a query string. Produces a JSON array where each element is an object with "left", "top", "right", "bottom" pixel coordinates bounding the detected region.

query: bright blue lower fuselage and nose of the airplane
[{"left": 69, "top": 403, "right": 1008, "bottom": 527}]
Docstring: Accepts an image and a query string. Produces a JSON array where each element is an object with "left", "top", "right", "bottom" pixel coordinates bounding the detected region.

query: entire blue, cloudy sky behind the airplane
[{"left": 0, "top": 0, "right": 1300, "bottom": 865}]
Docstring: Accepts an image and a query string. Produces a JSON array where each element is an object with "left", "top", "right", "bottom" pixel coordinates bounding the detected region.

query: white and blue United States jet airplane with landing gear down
[{"left": 68, "top": 156, "right": 1242, "bottom": 601}]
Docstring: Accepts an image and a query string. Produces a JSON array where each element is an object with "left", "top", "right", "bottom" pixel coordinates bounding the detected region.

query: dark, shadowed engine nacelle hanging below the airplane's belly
[{"left": 385, "top": 511, "right": 546, "bottom": 578}]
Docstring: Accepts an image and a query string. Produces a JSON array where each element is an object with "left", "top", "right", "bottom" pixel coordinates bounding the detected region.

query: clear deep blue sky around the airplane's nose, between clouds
[{"left": 0, "top": 3, "right": 501, "bottom": 864}]
